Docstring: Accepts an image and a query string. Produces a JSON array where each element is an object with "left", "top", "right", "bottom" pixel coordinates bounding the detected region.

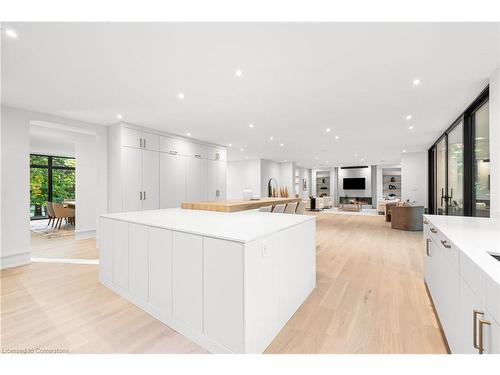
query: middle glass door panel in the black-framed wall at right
[{"left": 445, "top": 121, "right": 464, "bottom": 216}]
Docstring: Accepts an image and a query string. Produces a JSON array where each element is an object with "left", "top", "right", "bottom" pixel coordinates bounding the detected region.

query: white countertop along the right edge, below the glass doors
[{"left": 424, "top": 214, "right": 500, "bottom": 285}]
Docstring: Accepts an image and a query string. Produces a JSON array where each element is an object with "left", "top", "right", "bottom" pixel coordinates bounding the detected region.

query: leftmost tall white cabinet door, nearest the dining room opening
[{"left": 122, "top": 147, "right": 142, "bottom": 212}]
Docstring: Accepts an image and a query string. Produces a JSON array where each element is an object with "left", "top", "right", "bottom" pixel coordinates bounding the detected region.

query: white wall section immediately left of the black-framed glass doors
[{"left": 401, "top": 151, "right": 427, "bottom": 206}]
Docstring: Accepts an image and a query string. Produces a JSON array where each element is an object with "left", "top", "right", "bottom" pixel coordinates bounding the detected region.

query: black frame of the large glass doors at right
[{"left": 427, "top": 85, "right": 489, "bottom": 216}]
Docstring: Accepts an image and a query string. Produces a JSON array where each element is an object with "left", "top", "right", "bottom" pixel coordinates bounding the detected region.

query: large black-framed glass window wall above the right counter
[{"left": 429, "top": 87, "right": 490, "bottom": 217}]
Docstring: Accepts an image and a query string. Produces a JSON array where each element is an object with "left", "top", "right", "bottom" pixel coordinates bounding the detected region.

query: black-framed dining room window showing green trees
[{"left": 30, "top": 154, "right": 76, "bottom": 220}]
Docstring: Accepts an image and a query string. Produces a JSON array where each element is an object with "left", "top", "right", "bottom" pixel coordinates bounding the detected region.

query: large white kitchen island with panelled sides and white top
[{"left": 99, "top": 209, "right": 316, "bottom": 353}]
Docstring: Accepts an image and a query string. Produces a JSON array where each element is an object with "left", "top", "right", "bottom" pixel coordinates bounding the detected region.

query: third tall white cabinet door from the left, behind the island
[{"left": 160, "top": 152, "right": 186, "bottom": 208}]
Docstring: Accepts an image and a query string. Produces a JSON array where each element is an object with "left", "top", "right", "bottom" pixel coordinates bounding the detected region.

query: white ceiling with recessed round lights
[{"left": 2, "top": 23, "right": 500, "bottom": 167}]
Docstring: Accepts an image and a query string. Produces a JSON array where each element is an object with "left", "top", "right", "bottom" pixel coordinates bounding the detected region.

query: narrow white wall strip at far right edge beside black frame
[{"left": 489, "top": 67, "right": 500, "bottom": 213}]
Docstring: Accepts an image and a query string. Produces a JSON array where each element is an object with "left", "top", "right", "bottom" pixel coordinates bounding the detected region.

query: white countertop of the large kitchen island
[{"left": 101, "top": 208, "right": 315, "bottom": 242}]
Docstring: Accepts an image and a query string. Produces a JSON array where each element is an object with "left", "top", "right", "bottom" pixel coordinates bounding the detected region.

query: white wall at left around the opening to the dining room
[{"left": 1, "top": 106, "right": 107, "bottom": 268}]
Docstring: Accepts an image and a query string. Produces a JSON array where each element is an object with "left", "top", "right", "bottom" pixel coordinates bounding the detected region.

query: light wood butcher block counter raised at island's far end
[{"left": 181, "top": 198, "right": 301, "bottom": 212}]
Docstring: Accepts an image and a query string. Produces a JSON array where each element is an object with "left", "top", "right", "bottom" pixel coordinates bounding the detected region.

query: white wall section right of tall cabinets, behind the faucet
[{"left": 227, "top": 159, "right": 261, "bottom": 199}]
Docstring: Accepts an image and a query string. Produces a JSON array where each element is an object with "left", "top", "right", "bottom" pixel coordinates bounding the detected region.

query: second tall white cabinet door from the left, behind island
[{"left": 142, "top": 150, "right": 160, "bottom": 210}]
